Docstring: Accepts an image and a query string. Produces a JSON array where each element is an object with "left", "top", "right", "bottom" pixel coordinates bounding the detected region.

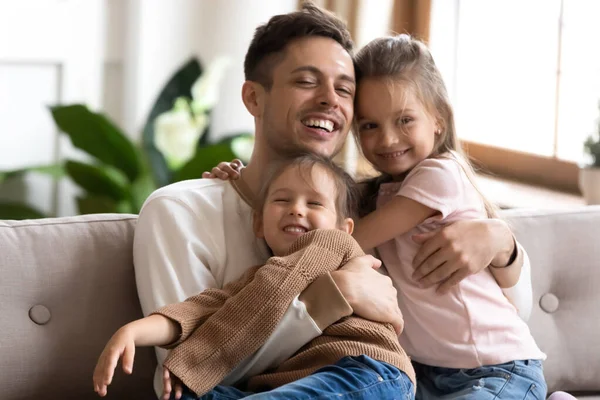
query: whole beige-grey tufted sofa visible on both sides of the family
[{"left": 0, "top": 207, "right": 600, "bottom": 400}]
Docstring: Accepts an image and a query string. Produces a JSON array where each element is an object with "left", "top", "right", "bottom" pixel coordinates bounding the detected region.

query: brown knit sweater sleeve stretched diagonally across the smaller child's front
[{"left": 164, "top": 230, "right": 363, "bottom": 395}]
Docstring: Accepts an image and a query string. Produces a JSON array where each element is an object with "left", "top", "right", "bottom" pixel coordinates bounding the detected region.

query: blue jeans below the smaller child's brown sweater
[{"left": 176, "top": 356, "right": 415, "bottom": 400}]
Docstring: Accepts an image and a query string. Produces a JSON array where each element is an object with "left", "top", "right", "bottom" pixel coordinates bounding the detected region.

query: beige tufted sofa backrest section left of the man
[{"left": 0, "top": 215, "right": 156, "bottom": 400}]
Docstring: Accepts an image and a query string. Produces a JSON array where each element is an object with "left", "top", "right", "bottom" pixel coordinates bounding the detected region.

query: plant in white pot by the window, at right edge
[{"left": 579, "top": 102, "right": 600, "bottom": 204}]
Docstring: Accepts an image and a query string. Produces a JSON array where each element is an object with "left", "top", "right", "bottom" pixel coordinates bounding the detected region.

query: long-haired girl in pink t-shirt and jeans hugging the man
[{"left": 354, "top": 35, "right": 547, "bottom": 400}]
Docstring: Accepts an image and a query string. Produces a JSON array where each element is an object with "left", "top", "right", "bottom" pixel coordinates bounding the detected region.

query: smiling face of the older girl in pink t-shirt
[{"left": 356, "top": 78, "right": 439, "bottom": 178}]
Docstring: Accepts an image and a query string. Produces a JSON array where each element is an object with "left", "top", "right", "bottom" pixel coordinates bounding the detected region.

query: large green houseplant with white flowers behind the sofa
[{"left": 0, "top": 59, "right": 253, "bottom": 219}]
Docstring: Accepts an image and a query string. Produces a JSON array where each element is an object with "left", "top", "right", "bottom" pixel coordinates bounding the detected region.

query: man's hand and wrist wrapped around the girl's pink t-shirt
[{"left": 413, "top": 219, "right": 514, "bottom": 293}]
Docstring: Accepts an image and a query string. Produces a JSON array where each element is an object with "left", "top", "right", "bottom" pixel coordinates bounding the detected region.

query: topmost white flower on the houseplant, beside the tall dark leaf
[{"left": 192, "top": 57, "right": 231, "bottom": 115}]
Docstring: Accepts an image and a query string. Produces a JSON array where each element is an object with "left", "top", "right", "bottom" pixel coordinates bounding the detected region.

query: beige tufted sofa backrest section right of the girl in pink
[{"left": 503, "top": 207, "right": 600, "bottom": 393}]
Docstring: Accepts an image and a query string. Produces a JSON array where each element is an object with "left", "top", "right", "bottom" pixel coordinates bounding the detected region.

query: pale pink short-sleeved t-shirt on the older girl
[{"left": 377, "top": 155, "right": 546, "bottom": 368}]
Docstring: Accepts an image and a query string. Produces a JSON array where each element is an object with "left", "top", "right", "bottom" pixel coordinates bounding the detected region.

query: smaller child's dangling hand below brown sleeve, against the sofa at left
[{"left": 94, "top": 328, "right": 135, "bottom": 397}]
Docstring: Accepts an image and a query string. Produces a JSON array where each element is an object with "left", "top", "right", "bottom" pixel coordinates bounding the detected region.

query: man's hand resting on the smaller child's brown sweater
[{"left": 331, "top": 255, "right": 404, "bottom": 335}]
